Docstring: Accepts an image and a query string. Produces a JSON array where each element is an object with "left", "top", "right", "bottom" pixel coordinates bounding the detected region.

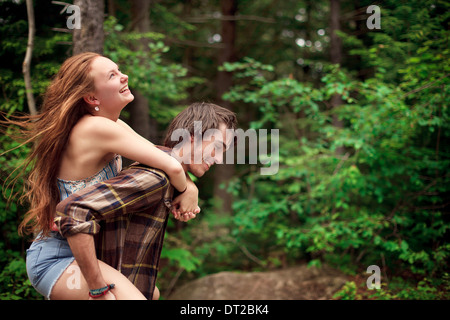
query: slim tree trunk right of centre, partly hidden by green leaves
[{"left": 330, "top": 0, "right": 343, "bottom": 155}]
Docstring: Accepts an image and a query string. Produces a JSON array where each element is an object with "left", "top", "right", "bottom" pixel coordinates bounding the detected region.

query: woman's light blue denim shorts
[{"left": 26, "top": 231, "right": 75, "bottom": 300}]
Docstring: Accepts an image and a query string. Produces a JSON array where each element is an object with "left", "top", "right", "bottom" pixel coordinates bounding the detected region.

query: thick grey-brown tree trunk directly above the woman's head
[{"left": 73, "top": 0, "right": 105, "bottom": 55}]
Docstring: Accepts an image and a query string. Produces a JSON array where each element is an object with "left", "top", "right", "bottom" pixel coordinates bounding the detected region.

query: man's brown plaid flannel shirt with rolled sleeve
[{"left": 55, "top": 164, "right": 174, "bottom": 299}]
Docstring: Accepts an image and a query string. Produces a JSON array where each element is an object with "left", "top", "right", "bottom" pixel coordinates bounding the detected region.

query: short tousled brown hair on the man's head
[{"left": 164, "top": 102, "right": 237, "bottom": 148}]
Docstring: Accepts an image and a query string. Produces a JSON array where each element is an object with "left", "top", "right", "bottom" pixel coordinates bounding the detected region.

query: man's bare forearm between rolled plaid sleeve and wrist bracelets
[{"left": 67, "top": 233, "right": 107, "bottom": 290}]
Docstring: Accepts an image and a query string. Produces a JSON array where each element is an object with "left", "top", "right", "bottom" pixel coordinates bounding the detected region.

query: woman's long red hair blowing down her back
[{"left": 2, "top": 52, "right": 100, "bottom": 235}]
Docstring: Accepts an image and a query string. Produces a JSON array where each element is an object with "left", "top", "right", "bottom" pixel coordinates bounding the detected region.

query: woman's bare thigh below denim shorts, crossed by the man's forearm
[{"left": 50, "top": 260, "right": 146, "bottom": 300}]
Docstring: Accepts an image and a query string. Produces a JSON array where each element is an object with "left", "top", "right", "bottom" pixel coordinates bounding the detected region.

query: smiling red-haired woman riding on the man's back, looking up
[{"left": 6, "top": 53, "right": 198, "bottom": 299}]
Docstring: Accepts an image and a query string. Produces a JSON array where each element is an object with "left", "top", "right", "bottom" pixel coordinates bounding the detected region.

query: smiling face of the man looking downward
[{"left": 183, "top": 123, "right": 234, "bottom": 177}]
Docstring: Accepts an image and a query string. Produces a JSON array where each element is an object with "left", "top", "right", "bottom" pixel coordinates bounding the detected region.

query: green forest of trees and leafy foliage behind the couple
[{"left": 0, "top": 0, "right": 450, "bottom": 299}]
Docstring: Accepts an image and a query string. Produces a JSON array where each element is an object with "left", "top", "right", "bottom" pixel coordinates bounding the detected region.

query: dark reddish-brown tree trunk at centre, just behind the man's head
[{"left": 214, "top": 0, "right": 237, "bottom": 213}]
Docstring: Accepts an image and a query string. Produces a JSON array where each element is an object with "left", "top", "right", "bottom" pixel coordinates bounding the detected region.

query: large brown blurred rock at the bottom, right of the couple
[{"left": 168, "top": 265, "right": 348, "bottom": 300}]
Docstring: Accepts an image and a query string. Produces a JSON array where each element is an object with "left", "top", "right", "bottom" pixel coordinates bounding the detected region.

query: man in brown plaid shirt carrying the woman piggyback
[{"left": 56, "top": 103, "right": 237, "bottom": 299}]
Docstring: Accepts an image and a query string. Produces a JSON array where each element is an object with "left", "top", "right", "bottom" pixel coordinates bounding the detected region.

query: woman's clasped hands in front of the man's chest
[{"left": 171, "top": 182, "right": 200, "bottom": 222}]
